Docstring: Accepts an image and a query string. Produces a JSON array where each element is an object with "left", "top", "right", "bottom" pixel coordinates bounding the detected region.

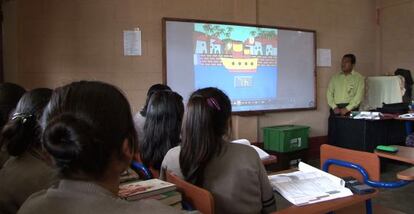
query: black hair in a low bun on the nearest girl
[{"left": 43, "top": 81, "right": 136, "bottom": 179}]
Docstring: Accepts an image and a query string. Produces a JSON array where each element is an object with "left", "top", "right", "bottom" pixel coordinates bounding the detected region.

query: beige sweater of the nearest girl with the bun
[{"left": 18, "top": 180, "right": 180, "bottom": 214}]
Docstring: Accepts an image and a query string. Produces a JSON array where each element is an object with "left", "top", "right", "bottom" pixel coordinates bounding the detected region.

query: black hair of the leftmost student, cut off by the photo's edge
[{"left": 0, "top": 82, "right": 26, "bottom": 128}]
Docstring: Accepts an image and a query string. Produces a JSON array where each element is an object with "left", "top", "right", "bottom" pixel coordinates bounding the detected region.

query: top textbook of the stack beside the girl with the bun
[{"left": 118, "top": 178, "right": 176, "bottom": 201}]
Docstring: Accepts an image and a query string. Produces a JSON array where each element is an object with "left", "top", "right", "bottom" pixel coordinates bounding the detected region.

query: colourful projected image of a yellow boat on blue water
[{"left": 193, "top": 23, "right": 278, "bottom": 111}]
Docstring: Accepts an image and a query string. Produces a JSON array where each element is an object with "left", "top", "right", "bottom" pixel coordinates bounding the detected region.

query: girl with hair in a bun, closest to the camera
[{"left": 18, "top": 81, "right": 178, "bottom": 214}]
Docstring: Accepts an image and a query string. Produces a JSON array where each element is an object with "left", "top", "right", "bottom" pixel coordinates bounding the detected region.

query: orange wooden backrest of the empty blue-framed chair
[{"left": 321, "top": 144, "right": 380, "bottom": 181}]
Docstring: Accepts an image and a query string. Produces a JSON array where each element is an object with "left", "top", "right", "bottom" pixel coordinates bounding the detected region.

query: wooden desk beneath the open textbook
[{"left": 270, "top": 169, "right": 379, "bottom": 214}]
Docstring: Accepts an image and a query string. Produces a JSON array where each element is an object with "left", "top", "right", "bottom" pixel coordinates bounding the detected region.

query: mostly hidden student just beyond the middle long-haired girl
[{"left": 134, "top": 84, "right": 171, "bottom": 144}]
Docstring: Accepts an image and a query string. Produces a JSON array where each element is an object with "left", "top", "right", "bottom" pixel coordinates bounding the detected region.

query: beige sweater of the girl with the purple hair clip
[{"left": 161, "top": 143, "right": 276, "bottom": 213}]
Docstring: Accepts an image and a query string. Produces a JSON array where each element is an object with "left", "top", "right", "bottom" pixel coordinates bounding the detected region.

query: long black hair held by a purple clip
[{"left": 179, "top": 88, "right": 231, "bottom": 186}]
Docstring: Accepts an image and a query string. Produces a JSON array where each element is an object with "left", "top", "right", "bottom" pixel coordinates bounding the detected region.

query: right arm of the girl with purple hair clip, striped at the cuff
[{"left": 259, "top": 159, "right": 276, "bottom": 213}]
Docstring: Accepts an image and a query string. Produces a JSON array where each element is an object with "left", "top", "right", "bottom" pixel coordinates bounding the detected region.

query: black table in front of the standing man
[{"left": 328, "top": 116, "right": 406, "bottom": 152}]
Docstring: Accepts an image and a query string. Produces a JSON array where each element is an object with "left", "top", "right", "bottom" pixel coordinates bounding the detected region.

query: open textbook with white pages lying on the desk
[{"left": 269, "top": 162, "right": 352, "bottom": 206}]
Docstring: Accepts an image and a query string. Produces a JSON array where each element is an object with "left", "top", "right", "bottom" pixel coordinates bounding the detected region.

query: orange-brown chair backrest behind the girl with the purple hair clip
[{"left": 166, "top": 172, "right": 214, "bottom": 214}]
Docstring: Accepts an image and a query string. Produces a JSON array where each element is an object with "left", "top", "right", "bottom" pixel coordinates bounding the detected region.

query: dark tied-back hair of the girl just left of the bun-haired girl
[{"left": 0, "top": 88, "right": 52, "bottom": 156}]
